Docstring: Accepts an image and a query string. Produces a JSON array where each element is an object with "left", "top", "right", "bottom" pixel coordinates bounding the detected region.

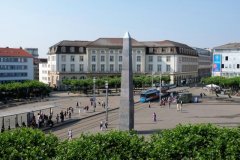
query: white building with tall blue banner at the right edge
[{"left": 212, "top": 43, "right": 240, "bottom": 77}]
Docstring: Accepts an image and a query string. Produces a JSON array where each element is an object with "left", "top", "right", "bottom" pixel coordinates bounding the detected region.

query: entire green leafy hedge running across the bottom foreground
[{"left": 0, "top": 124, "right": 240, "bottom": 160}]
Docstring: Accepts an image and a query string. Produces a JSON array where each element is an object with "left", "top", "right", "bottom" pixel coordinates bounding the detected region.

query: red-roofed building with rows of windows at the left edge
[{"left": 0, "top": 47, "right": 33, "bottom": 83}]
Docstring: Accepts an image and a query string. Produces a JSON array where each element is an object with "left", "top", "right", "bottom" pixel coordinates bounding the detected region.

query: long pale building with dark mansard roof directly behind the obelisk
[{"left": 48, "top": 38, "right": 202, "bottom": 89}]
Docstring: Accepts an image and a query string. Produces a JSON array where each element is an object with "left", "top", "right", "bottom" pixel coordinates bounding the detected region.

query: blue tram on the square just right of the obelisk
[{"left": 140, "top": 89, "right": 160, "bottom": 103}]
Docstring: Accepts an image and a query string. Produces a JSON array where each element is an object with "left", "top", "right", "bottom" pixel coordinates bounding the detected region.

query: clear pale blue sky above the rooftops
[{"left": 0, "top": 0, "right": 240, "bottom": 57}]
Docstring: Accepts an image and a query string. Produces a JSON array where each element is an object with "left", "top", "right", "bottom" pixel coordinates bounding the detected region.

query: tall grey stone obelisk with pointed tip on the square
[{"left": 119, "top": 32, "right": 134, "bottom": 130}]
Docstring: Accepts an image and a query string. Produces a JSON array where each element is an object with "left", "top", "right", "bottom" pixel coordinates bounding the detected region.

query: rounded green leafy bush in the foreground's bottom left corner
[{"left": 0, "top": 128, "right": 58, "bottom": 160}]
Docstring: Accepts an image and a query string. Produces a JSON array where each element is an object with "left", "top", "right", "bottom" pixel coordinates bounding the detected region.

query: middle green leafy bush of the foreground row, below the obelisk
[{"left": 57, "top": 131, "right": 148, "bottom": 160}]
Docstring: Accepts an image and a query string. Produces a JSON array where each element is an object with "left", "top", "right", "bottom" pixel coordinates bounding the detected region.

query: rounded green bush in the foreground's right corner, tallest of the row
[{"left": 149, "top": 124, "right": 240, "bottom": 159}]
